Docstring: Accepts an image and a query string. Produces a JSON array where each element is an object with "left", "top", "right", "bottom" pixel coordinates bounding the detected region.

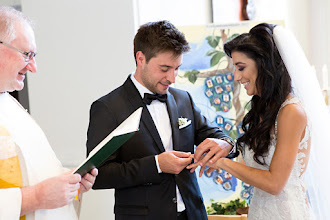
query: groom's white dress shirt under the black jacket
[{"left": 131, "top": 73, "right": 186, "bottom": 212}]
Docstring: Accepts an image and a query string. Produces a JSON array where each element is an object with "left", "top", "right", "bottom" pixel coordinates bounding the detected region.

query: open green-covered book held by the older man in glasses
[{"left": 72, "top": 107, "right": 142, "bottom": 176}]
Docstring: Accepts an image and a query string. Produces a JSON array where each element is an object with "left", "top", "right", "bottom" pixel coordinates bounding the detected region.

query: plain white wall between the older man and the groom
[{"left": 22, "top": 0, "right": 135, "bottom": 219}]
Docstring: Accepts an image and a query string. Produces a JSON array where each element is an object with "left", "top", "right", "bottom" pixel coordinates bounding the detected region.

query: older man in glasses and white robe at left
[{"left": 0, "top": 6, "right": 97, "bottom": 220}]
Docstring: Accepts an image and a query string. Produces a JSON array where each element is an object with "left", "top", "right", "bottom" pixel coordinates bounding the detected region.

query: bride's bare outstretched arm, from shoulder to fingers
[{"left": 187, "top": 104, "right": 307, "bottom": 195}]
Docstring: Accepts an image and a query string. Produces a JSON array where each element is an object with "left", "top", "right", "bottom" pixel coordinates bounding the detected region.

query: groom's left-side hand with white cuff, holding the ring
[{"left": 158, "top": 151, "right": 192, "bottom": 174}]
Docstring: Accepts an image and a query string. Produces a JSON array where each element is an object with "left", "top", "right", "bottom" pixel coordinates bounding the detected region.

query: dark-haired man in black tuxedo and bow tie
[{"left": 87, "top": 21, "right": 235, "bottom": 220}]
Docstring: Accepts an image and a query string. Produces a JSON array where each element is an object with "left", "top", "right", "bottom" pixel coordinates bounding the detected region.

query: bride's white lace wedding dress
[{"left": 243, "top": 97, "right": 312, "bottom": 220}]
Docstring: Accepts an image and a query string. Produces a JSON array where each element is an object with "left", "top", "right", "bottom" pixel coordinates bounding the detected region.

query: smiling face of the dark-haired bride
[{"left": 231, "top": 51, "right": 259, "bottom": 95}]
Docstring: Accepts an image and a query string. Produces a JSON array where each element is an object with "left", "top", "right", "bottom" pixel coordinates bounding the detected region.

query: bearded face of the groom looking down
[{"left": 137, "top": 52, "right": 182, "bottom": 94}]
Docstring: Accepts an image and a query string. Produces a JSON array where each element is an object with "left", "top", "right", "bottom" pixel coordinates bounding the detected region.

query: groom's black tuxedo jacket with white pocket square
[{"left": 87, "top": 77, "right": 233, "bottom": 220}]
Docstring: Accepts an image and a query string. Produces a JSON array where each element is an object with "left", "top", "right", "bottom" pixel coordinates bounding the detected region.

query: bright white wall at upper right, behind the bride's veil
[{"left": 286, "top": 0, "right": 330, "bottom": 89}]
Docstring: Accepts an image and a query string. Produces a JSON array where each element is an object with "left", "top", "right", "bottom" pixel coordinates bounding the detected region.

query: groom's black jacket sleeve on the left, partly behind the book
[{"left": 87, "top": 101, "right": 161, "bottom": 189}]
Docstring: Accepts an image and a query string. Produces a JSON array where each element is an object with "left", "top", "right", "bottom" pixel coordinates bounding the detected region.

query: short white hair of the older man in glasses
[{"left": 0, "top": 6, "right": 34, "bottom": 43}]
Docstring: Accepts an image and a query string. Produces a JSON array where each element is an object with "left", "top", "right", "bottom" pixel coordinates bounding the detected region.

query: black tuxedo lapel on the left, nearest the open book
[{"left": 124, "top": 76, "right": 165, "bottom": 152}]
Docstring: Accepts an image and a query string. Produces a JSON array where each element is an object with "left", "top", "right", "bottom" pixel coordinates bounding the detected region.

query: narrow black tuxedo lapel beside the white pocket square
[{"left": 166, "top": 92, "right": 180, "bottom": 150}]
